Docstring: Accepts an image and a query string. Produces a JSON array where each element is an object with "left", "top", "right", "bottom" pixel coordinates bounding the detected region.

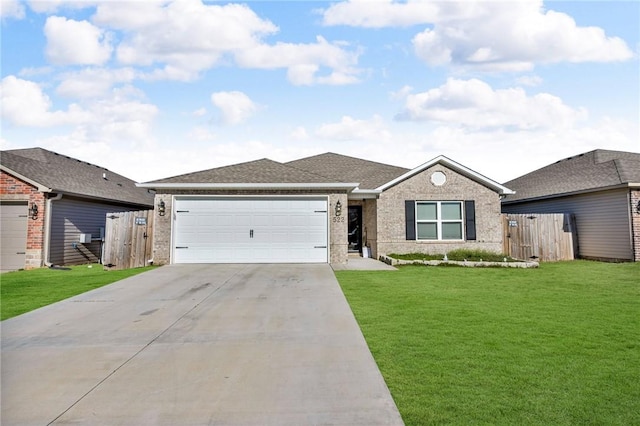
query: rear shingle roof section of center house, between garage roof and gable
[{"left": 285, "top": 152, "right": 409, "bottom": 189}]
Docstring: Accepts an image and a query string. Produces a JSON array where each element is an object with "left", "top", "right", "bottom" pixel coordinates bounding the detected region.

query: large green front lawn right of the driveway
[{"left": 336, "top": 261, "right": 640, "bottom": 425}]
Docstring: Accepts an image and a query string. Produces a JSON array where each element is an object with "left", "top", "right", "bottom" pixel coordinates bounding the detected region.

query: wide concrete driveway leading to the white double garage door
[{"left": 1, "top": 265, "right": 402, "bottom": 425}]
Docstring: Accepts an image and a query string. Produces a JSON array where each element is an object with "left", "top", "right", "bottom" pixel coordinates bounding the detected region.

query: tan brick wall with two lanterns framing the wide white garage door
[{"left": 153, "top": 191, "right": 348, "bottom": 265}]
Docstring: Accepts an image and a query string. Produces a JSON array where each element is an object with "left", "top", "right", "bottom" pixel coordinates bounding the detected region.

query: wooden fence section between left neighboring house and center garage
[{"left": 102, "top": 210, "right": 153, "bottom": 269}]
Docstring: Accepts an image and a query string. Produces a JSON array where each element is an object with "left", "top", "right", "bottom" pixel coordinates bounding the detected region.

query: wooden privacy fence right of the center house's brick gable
[{"left": 502, "top": 213, "right": 578, "bottom": 262}]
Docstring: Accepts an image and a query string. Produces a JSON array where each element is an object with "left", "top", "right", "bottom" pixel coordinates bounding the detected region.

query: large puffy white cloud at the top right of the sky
[{"left": 413, "top": 1, "right": 633, "bottom": 71}]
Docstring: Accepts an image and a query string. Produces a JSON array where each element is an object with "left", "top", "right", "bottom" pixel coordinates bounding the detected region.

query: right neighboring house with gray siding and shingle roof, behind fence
[{"left": 502, "top": 149, "right": 640, "bottom": 262}]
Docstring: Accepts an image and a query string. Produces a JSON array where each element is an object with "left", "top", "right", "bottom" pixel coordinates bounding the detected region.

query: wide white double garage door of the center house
[{"left": 173, "top": 198, "right": 328, "bottom": 263}]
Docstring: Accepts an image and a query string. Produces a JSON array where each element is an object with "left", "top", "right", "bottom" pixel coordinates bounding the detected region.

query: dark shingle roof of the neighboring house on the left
[{"left": 0, "top": 148, "right": 154, "bottom": 206}]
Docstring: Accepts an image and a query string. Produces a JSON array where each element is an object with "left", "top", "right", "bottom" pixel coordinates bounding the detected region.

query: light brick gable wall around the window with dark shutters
[{"left": 374, "top": 164, "right": 502, "bottom": 257}]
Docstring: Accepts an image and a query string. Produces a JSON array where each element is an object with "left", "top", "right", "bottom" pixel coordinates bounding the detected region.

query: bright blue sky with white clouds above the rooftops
[{"left": 0, "top": 0, "right": 640, "bottom": 182}]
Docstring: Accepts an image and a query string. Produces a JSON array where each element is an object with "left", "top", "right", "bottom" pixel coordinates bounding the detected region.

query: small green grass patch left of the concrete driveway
[{"left": 0, "top": 265, "right": 153, "bottom": 320}]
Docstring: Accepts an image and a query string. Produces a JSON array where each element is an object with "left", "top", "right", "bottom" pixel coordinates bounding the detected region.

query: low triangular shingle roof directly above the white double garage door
[{"left": 147, "top": 158, "right": 332, "bottom": 184}]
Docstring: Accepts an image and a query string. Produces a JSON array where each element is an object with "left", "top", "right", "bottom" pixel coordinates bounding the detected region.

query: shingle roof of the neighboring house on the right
[{"left": 503, "top": 149, "right": 640, "bottom": 203}]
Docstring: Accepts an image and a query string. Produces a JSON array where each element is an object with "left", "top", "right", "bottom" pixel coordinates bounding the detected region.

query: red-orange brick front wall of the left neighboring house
[{"left": 0, "top": 170, "right": 46, "bottom": 269}]
